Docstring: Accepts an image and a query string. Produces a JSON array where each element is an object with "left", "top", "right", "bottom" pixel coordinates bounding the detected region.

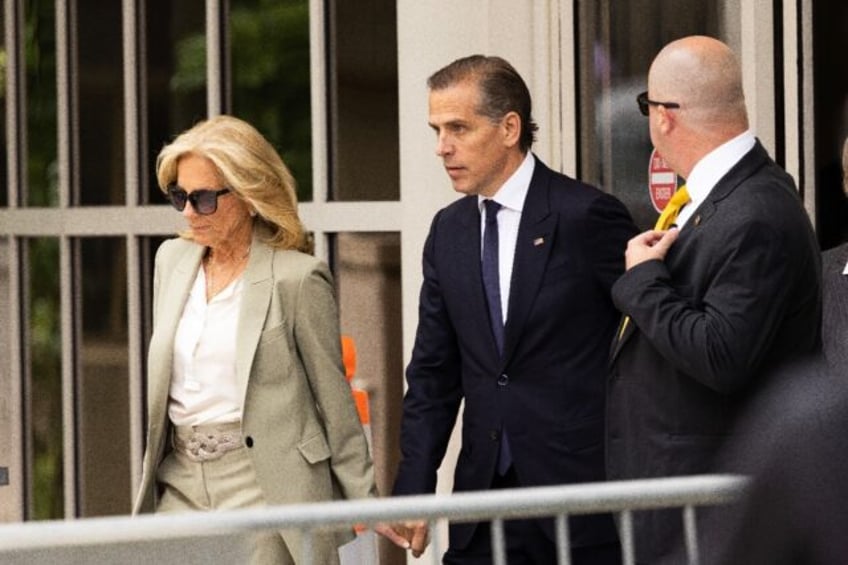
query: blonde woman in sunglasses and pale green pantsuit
[{"left": 134, "top": 116, "right": 394, "bottom": 563}]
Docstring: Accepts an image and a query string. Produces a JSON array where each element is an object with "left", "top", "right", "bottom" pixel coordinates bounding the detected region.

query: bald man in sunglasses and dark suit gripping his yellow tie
[{"left": 607, "top": 36, "right": 821, "bottom": 563}]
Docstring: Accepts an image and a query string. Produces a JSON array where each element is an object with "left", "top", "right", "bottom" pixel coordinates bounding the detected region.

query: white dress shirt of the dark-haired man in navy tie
[{"left": 477, "top": 151, "right": 536, "bottom": 325}]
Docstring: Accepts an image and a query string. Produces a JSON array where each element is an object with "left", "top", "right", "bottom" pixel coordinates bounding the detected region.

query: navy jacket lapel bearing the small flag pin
[{"left": 504, "top": 159, "right": 557, "bottom": 359}]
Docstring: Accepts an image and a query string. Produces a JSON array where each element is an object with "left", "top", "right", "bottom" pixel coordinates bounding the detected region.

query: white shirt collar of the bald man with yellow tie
[{"left": 674, "top": 130, "right": 757, "bottom": 228}]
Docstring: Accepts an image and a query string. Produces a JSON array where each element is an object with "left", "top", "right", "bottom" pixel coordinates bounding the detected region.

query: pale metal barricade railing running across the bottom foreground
[{"left": 0, "top": 475, "right": 747, "bottom": 565}]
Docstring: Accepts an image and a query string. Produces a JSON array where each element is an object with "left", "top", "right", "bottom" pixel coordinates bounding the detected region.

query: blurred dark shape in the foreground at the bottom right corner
[{"left": 704, "top": 356, "right": 848, "bottom": 565}]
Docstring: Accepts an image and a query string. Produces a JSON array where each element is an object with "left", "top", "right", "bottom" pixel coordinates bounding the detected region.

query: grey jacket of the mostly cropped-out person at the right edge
[{"left": 822, "top": 243, "right": 848, "bottom": 375}]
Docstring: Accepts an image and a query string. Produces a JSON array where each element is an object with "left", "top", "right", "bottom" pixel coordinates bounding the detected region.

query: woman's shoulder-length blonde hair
[{"left": 156, "top": 115, "right": 311, "bottom": 252}]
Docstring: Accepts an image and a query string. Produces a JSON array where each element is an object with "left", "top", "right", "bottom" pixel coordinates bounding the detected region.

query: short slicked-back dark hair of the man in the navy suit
[{"left": 427, "top": 55, "right": 539, "bottom": 152}]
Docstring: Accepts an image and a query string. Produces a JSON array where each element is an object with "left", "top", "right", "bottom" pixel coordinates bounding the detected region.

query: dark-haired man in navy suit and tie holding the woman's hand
[{"left": 394, "top": 55, "right": 636, "bottom": 565}]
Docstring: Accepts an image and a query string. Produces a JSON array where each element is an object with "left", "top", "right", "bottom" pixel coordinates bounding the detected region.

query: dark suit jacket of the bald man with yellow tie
[{"left": 607, "top": 143, "right": 821, "bottom": 563}]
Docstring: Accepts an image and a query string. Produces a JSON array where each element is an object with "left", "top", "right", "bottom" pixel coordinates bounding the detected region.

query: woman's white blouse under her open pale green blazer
[{"left": 168, "top": 267, "right": 244, "bottom": 426}]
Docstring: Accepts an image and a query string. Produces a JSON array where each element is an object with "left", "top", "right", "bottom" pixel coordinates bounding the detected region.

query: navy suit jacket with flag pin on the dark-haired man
[{"left": 394, "top": 155, "right": 635, "bottom": 548}]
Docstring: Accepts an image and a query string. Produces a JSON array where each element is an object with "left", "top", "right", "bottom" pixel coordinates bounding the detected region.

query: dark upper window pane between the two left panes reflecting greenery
[{"left": 76, "top": 0, "right": 126, "bottom": 205}]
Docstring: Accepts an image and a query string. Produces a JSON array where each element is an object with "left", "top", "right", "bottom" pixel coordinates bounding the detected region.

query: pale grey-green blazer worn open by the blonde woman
[{"left": 133, "top": 227, "right": 376, "bottom": 563}]
